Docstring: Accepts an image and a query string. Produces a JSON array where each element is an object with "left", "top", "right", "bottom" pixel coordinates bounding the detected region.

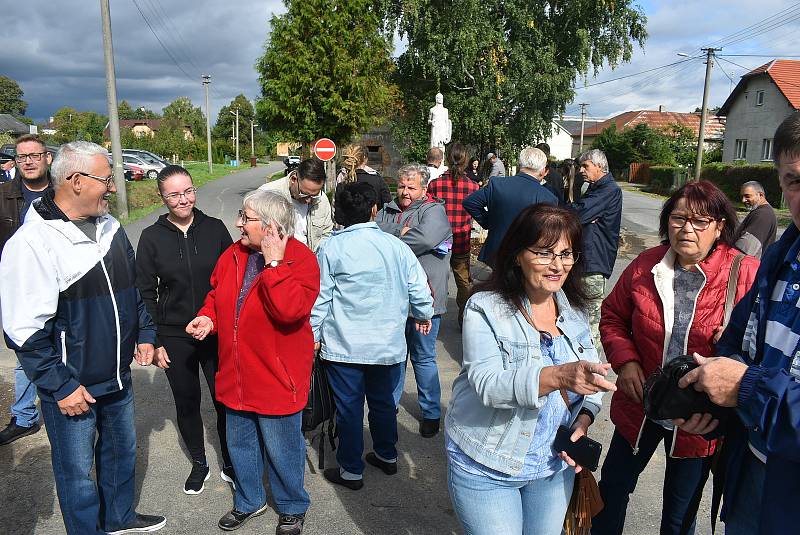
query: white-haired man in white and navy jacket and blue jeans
[{"left": 0, "top": 141, "right": 166, "bottom": 535}]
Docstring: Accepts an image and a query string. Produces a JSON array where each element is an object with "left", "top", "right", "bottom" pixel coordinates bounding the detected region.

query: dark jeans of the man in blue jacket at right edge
[{"left": 725, "top": 448, "right": 764, "bottom": 535}]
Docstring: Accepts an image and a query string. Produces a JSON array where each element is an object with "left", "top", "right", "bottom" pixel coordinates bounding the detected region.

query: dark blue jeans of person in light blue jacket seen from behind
[{"left": 325, "top": 361, "right": 402, "bottom": 479}]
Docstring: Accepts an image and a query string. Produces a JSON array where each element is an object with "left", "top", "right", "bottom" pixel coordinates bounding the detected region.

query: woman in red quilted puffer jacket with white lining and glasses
[{"left": 592, "top": 181, "right": 758, "bottom": 535}]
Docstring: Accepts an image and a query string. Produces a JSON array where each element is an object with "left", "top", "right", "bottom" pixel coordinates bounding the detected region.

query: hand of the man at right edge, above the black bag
[{"left": 678, "top": 353, "right": 747, "bottom": 407}]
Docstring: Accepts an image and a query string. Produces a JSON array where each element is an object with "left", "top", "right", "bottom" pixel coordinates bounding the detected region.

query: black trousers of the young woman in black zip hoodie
[{"left": 160, "top": 336, "right": 231, "bottom": 466}]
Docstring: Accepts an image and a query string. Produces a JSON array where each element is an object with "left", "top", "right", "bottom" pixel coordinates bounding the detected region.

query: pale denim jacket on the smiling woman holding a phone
[{"left": 445, "top": 291, "right": 602, "bottom": 475}]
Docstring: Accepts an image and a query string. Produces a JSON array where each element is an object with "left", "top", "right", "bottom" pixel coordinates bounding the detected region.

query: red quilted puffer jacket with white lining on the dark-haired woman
[{"left": 600, "top": 243, "right": 758, "bottom": 457}]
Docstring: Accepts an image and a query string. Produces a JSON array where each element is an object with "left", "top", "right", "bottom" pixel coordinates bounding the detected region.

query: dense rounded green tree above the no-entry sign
[{"left": 256, "top": 0, "right": 395, "bottom": 149}]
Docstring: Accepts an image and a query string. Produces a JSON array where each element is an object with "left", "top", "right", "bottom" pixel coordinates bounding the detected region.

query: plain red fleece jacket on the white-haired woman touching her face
[{"left": 197, "top": 238, "right": 319, "bottom": 415}]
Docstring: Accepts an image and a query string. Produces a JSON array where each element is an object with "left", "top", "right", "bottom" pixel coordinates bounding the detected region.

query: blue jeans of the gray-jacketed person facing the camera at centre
[{"left": 394, "top": 316, "right": 442, "bottom": 420}]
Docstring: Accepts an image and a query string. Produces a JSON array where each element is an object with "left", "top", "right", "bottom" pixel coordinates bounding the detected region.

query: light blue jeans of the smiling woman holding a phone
[{"left": 447, "top": 463, "right": 575, "bottom": 535}]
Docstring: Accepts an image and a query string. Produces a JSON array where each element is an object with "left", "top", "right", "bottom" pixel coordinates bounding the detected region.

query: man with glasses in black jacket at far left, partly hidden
[{"left": 0, "top": 134, "right": 53, "bottom": 446}]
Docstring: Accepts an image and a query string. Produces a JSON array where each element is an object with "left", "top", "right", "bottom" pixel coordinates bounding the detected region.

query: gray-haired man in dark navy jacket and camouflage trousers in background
[{"left": 572, "top": 149, "right": 622, "bottom": 349}]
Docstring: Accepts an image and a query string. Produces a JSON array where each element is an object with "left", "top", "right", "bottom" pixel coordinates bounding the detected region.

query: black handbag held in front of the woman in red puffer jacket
[{"left": 644, "top": 355, "right": 731, "bottom": 420}]
